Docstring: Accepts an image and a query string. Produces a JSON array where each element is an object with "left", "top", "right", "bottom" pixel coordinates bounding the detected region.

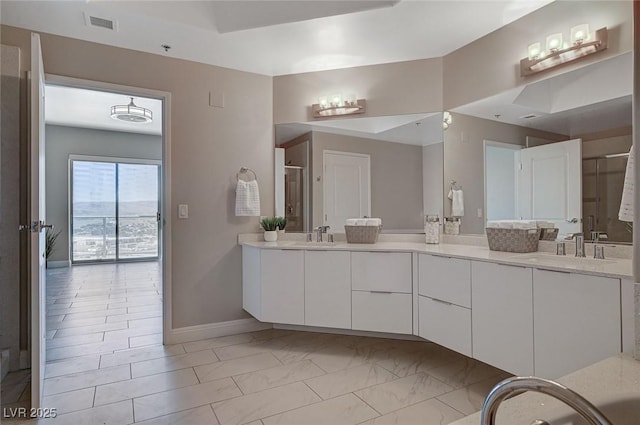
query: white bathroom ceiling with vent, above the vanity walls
[{"left": 1, "top": 0, "right": 551, "bottom": 75}]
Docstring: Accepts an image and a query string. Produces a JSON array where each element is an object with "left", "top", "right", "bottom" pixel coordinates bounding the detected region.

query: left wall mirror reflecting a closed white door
[{"left": 275, "top": 112, "right": 443, "bottom": 233}]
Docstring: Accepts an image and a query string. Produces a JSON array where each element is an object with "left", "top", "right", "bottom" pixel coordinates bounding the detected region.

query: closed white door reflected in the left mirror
[{"left": 323, "top": 151, "right": 371, "bottom": 233}]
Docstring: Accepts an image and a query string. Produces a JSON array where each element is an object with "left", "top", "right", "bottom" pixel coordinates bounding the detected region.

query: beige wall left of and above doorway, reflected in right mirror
[{"left": 444, "top": 113, "right": 567, "bottom": 233}]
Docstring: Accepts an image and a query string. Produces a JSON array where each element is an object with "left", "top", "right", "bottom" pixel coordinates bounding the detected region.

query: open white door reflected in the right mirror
[{"left": 518, "top": 139, "right": 582, "bottom": 234}]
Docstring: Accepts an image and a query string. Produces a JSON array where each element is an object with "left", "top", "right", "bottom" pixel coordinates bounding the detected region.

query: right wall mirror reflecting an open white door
[{"left": 443, "top": 53, "right": 633, "bottom": 243}]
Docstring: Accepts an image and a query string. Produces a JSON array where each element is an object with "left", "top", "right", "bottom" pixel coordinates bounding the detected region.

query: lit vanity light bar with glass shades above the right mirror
[{"left": 520, "top": 24, "right": 607, "bottom": 77}]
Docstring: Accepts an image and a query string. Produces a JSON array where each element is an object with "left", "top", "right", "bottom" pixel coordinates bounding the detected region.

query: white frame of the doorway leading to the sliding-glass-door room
[{"left": 45, "top": 73, "right": 173, "bottom": 344}]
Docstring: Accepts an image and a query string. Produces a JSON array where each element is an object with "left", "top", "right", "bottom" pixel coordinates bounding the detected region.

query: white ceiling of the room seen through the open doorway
[{"left": 44, "top": 85, "right": 162, "bottom": 135}]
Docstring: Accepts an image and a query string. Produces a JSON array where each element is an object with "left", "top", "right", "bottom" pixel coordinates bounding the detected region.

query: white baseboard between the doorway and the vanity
[{"left": 164, "top": 318, "right": 273, "bottom": 344}]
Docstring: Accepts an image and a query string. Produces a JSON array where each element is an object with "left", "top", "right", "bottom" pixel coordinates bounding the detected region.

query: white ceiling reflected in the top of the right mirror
[{"left": 452, "top": 53, "right": 633, "bottom": 137}]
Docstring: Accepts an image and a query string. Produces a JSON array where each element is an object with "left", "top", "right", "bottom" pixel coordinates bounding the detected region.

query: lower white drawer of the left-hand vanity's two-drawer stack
[{"left": 351, "top": 291, "right": 413, "bottom": 335}]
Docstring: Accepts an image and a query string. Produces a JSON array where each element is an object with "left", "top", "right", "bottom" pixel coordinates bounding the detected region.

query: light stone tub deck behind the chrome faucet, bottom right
[{"left": 451, "top": 354, "right": 640, "bottom": 425}]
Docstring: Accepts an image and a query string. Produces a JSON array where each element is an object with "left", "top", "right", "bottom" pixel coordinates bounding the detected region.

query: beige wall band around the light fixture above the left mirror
[{"left": 273, "top": 58, "right": 442, "bottom": 124}]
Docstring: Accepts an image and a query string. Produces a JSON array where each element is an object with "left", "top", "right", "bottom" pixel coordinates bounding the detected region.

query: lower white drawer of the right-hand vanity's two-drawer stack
[{"left": 418, "top": 295, "right": 472, "bottom": 356}]
